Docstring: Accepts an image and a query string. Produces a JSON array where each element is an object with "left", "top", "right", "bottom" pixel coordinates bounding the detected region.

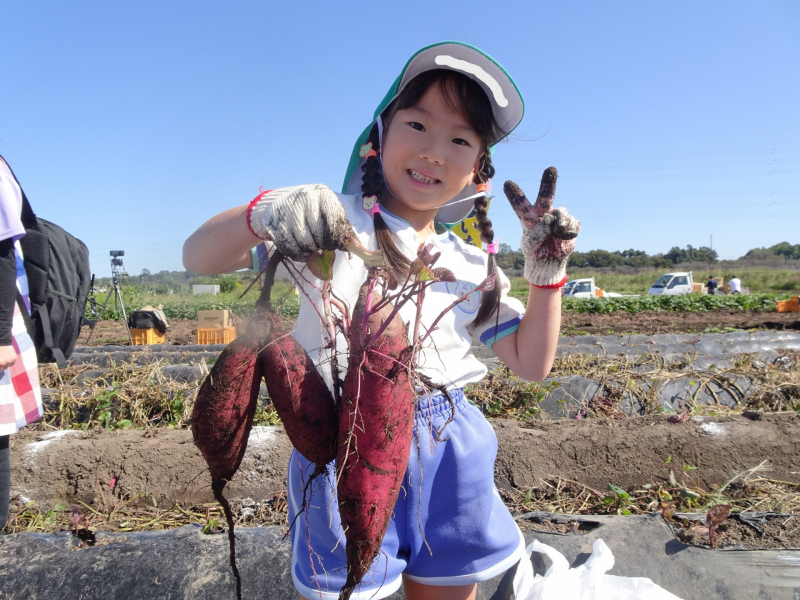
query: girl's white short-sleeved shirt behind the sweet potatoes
[{"left": 293, "top": 194, "right": 525, "bottom": 388}]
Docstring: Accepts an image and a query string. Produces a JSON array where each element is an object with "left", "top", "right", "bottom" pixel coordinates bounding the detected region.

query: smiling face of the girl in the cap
[{"left": 381, "top": 83, "right": 484, "bottom": 231}]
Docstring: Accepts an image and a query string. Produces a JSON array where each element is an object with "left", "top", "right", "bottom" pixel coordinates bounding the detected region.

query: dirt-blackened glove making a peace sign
[{"left": 503, "top": 167, "right": 581, "bottom": 287}]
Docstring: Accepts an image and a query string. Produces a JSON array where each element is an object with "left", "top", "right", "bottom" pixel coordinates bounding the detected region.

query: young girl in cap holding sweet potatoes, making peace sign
[{"left": 184, "top": 42, "right": 579, "bottom": 600}]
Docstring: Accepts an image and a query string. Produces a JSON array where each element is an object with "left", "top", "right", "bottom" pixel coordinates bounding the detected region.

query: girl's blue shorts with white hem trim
[{"left": 288, "top": 390, "right": 524, "bottom": 600}]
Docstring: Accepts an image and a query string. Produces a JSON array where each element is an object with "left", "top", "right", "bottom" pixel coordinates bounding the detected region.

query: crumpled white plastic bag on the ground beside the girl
[{"left": 514, "top": 539, "right": 680, "bottom": 600}]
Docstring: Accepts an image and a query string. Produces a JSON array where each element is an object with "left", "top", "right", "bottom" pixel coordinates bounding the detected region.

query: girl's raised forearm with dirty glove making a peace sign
[{"left": 492, "top": 167, "right": 580, "bottom": 381}]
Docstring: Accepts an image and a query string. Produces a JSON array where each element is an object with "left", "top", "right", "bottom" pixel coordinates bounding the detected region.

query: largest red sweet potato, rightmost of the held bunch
[{"left": 337, "top": 282, "right": 415, "bottom": 600}]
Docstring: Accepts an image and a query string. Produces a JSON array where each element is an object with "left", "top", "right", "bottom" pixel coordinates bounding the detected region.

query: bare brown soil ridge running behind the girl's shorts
[{"left": 11, "top": 414, "right": 800, "bottom": 508}]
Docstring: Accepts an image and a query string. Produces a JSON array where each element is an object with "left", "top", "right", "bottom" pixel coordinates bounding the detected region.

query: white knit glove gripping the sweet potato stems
[{"left": 247, "top": 184, "right": 355, "bottom": 262}]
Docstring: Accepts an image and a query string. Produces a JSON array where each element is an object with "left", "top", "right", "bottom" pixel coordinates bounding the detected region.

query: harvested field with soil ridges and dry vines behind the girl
[{"left": 0, "top": 298, "right": 800, "bottom": 600}]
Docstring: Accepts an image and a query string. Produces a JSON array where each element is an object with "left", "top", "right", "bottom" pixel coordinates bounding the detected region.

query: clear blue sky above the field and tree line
[{"left": 0, "top": 0, "right": 800, "bottom": 276}]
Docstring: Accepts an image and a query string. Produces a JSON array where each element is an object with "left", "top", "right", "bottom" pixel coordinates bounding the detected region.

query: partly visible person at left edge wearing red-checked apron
[{"left": 0, "top": 156, "right": 42, "bottom": 532}]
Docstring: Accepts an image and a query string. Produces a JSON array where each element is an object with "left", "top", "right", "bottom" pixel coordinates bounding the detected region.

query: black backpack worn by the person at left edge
[{"left": 4, "top": 157, "right": 91, "bottom": 367}]
